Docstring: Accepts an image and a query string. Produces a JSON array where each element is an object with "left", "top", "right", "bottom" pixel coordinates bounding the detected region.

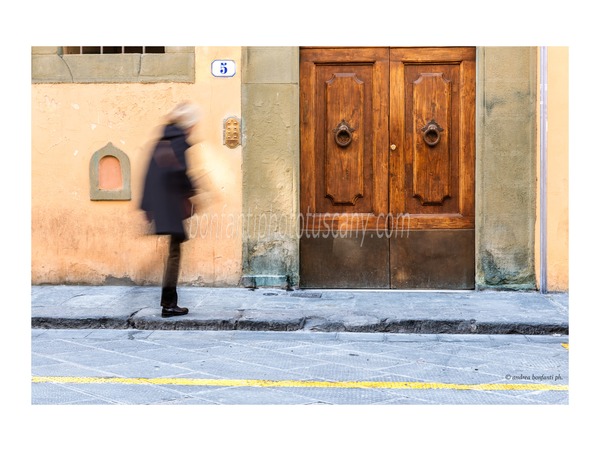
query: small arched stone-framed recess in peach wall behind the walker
[{"left": 90, "top": 142, "right": 131, "bottom": 200}]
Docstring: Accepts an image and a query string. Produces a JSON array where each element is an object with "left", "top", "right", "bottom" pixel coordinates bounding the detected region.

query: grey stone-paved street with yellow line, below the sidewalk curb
[{"left": 31, "top": 329, "right": 569, "bottom": 405}]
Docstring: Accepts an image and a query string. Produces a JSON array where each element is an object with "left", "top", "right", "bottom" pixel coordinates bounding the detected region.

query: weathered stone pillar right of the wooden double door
[{"left": 475, "top": 47, "right": 538, "bottom": 289}]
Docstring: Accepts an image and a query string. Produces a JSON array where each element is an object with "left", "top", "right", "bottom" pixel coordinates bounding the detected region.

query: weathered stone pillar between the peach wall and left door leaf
[{"left": 242, "top": 47, "right": 300, "bottom": 287}]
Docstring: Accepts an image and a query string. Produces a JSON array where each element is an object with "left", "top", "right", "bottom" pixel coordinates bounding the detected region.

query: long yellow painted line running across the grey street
[{"left": 32, "top": 377, "right": 569, "bottom": 391}]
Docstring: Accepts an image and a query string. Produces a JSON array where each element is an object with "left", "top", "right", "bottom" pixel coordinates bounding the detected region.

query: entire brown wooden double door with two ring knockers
[{"left": 300, "top": 47, "right": 475, "bottom": 289}]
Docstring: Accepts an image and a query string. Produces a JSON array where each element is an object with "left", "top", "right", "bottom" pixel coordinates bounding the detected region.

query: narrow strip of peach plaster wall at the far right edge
[{"left": 536, "top": 47, "right": 569, "bottom": 292}]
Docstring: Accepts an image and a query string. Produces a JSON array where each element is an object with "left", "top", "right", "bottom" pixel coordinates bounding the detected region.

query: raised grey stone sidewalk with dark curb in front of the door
[{"left": 31, "top": 285, "right": 569, "bottom": 335}]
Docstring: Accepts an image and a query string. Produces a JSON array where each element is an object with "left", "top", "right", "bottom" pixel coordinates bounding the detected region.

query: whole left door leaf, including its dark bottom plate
[{"left": 300, "top": 48, "right": 390, "bottom": 288}]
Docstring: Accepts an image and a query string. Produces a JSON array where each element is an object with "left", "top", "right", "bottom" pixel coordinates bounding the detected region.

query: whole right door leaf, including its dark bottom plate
[{"left": 390, "top": 48, "right": 475, "bottom": 289}]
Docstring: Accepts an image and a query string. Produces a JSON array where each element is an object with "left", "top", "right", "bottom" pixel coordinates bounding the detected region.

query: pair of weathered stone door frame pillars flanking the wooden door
[{"left": 241, "top": 47, "right": 538, "bottom": 289}]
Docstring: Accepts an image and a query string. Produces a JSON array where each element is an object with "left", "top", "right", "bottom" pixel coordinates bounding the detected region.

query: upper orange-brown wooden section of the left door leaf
[{"left": 300, "top": 48, "right": 389, "bottom": 232}]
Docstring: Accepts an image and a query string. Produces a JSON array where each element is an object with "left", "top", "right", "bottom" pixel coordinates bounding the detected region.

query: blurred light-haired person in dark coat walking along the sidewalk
[{"left": 140, "top": 102, "right": 200, "bottom": 317}]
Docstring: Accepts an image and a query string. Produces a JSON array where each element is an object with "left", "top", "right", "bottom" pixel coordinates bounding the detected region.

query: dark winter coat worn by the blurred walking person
[{"left": 141, "top": 125, "right": 194, "bottom": 237}]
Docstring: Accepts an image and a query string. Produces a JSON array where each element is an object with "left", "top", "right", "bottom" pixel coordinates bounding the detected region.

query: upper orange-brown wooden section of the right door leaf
[{"left": 390, "top": 48, "right": 475, "bottom": 229}]
